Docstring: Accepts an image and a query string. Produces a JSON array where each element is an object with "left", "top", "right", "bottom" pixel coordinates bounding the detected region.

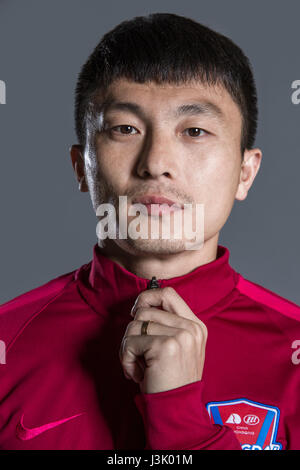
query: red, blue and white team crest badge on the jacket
[{"left": 206, "top": 398, "right": 282, "bottom": 450}]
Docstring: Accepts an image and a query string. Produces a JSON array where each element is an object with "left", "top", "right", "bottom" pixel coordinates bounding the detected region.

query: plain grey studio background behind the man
[{"left": 0, "top": 0, "right": 300, "bottom": 304}]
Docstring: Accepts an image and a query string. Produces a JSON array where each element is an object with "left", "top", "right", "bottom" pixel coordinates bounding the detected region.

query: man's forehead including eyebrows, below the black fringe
[{"left": 95, "top": 78, "right": 241, "bottom": 125}]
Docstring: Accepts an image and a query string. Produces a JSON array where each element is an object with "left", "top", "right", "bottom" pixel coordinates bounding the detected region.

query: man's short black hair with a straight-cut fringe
[{"left": 75, "top": 13, "right": 258, "bottom": 155}]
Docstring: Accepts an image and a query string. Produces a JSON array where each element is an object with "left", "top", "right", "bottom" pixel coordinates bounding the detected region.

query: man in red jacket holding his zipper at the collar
[{"left": 0, "top": 14, "right": 300, "bottom": 450}]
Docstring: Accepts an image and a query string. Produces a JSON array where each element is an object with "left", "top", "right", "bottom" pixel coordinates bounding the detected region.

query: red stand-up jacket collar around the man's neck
[{"left": 75, "top": 243, "right": 238, "bottom": 319}]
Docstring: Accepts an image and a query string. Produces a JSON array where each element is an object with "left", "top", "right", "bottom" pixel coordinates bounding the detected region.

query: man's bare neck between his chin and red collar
[{"left": 98, "top": 233, "right": 219, "bottom": 279}]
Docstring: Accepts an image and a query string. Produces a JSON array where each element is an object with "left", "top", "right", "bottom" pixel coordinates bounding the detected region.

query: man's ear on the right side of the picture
[{"left": 235, "top": 148, "right": 262, "bottom": 201}]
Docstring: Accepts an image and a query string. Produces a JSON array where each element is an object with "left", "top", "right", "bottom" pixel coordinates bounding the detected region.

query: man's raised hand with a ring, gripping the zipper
[{"left": 119, "top": 287, "right": 207, "bottom": 393}]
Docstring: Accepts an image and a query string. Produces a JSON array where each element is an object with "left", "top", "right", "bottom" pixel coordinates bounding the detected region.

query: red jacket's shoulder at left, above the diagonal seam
[{"left": 0, "top": 270, "right": 76, "bottom": 347}]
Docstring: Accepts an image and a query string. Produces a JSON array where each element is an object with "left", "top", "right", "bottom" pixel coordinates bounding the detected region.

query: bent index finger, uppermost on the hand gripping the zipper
[{"left": 131, "top": 287, "right": 202, "bottom": 323}]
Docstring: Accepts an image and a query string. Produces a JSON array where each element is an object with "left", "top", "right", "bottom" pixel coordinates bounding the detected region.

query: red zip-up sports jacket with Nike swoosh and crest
[{"left": 0, "top": 244, "right": 300, "bottom": 450}]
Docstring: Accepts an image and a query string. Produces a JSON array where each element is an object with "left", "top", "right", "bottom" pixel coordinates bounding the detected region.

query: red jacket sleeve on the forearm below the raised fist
[{"left": 134, "top": 380, "right": 242, "bottom": 450}]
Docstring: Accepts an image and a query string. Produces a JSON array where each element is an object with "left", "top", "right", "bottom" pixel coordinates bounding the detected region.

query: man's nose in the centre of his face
[{"left": 136, "top": 129, "right": 179, "bottom": 179}]
